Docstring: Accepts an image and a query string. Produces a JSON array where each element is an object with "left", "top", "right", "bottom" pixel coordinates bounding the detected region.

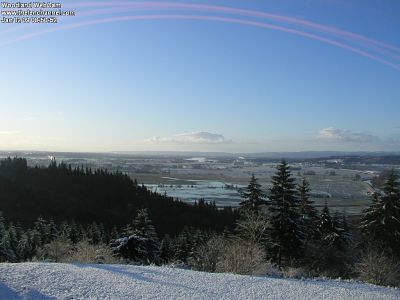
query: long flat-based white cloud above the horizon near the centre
[{"left": 148, "top": 131, "right": 233, "bottom": 144}]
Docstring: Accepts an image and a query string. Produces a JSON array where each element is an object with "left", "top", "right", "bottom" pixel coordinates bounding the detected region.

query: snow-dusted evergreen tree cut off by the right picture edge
[{"left": 360, "top": 170, "right": 400, "bottom": 255}]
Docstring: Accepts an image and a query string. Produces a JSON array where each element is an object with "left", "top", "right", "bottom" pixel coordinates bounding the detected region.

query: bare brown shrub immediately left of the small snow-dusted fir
[{"left": 64, "top": 241, "right": 119, "bottom": 264}]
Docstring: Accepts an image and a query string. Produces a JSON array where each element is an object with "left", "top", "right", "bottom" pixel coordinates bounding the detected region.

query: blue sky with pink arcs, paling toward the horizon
[{"left": 0, "top": 0, "right": 400, "bottom": 152}]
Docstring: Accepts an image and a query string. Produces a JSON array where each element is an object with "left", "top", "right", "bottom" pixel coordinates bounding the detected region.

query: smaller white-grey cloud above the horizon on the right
[{"left": 317, "top": 127, "right": 380, "bottom": 143}]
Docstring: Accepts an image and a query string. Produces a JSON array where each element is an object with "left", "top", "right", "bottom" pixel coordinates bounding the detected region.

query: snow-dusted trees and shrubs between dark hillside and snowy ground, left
[{"left": 0, "top": 209, "right": 215, "bottom": 264}]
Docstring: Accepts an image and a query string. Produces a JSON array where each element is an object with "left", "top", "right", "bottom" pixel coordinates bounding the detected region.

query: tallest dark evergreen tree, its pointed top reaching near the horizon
[{"left": 268, "top": 161, "right": 303, "bottom": 265}]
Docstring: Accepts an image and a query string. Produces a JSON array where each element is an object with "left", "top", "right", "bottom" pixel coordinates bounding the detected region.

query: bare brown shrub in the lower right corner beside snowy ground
[{"left": 355, "top": 250, "right": 400, "bottom": 286}]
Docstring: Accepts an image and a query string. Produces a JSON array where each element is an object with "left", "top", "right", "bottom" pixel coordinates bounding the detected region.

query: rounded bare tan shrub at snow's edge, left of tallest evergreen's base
[{"left": 216, "top": 241, "right": 266, "bottom": 275}]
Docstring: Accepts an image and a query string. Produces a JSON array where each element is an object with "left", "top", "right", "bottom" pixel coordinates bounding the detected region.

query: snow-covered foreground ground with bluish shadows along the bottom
[{"left": 0, "top": 263, "right": 400, "bottom": 300}]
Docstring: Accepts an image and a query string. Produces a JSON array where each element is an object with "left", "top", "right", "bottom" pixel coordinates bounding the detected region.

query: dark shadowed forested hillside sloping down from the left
[{"left": 0, "top": 158, "right": 237, "bottom": 237}]
